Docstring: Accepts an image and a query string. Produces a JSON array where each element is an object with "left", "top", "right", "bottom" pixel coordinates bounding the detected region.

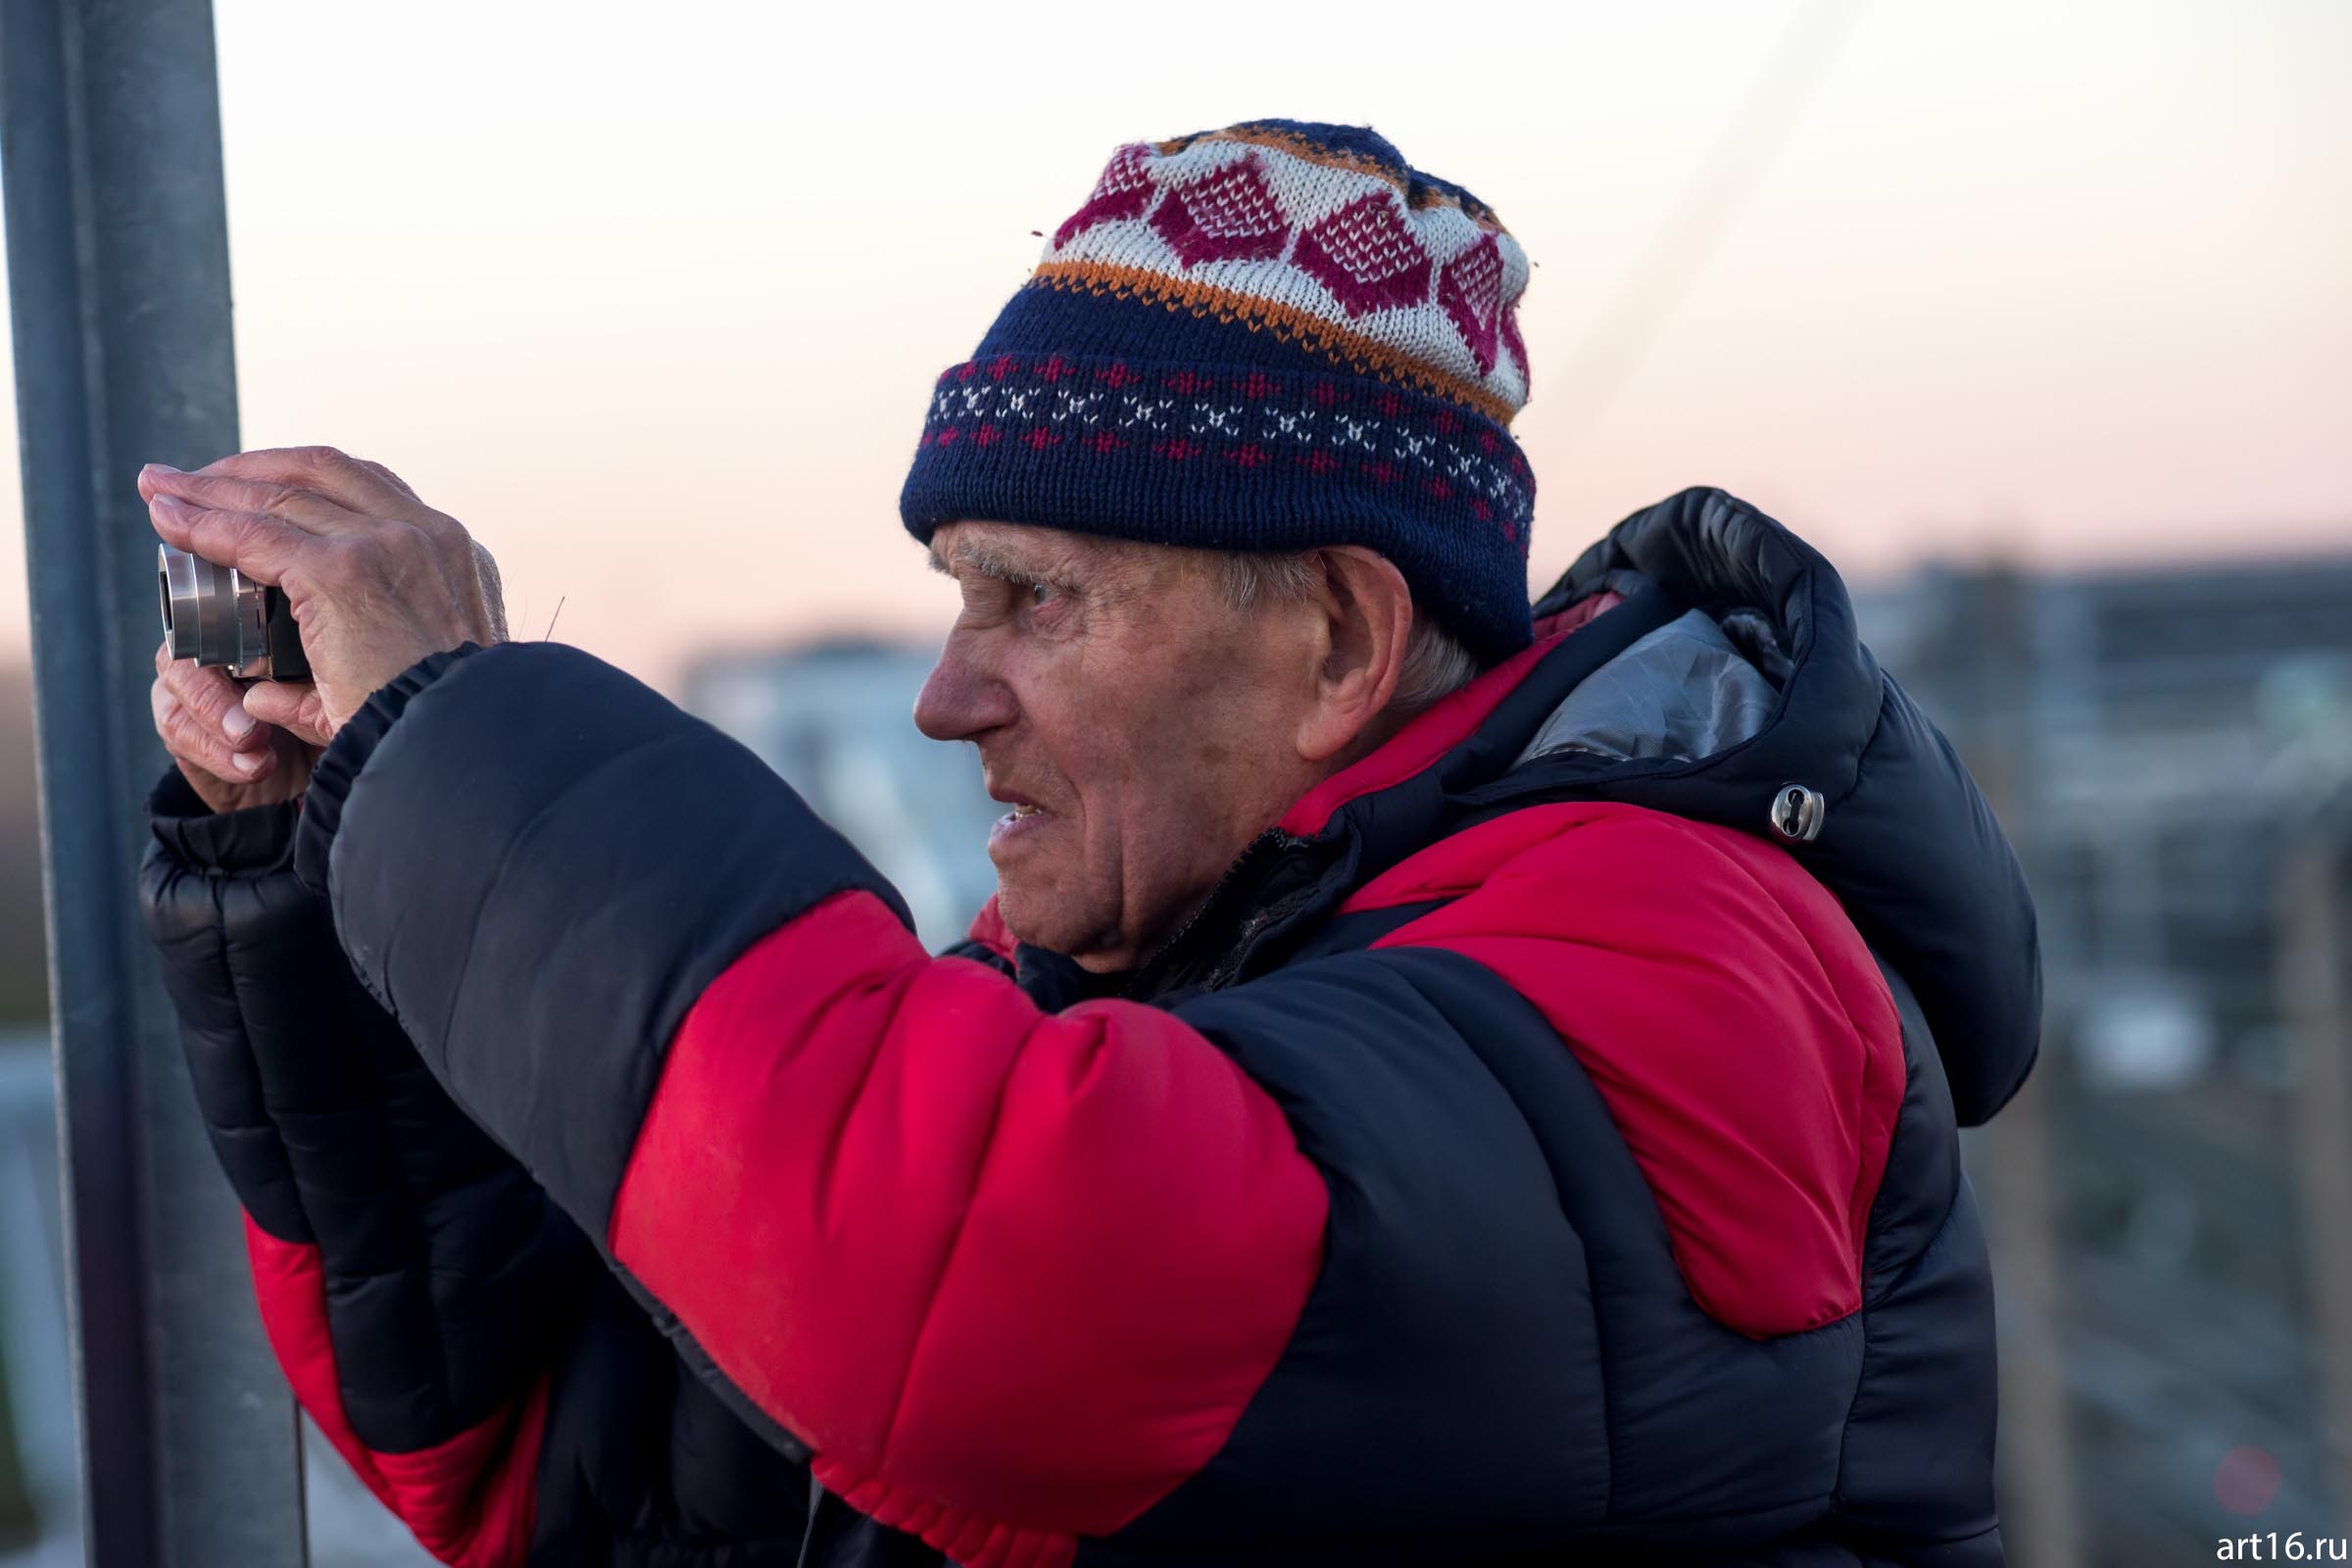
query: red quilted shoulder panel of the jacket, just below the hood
[{"left": 1350, "top": 802, "right": 1905, "bottom": 1336}]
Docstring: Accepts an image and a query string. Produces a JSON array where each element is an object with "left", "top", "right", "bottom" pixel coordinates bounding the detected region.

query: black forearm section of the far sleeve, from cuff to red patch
[{"left": 139, "top": 771, "right": 595, "bottom": 1452}]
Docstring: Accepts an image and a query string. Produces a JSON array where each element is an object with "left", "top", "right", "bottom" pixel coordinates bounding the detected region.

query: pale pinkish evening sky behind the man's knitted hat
[{"left": 0, "top": 0, "right": 2352, "bottom": 689}]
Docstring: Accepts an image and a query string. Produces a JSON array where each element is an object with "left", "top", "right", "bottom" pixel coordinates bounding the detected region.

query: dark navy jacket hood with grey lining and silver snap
[{"left": 1514, "top": 489, "right": 2041, "bottom": 1124}]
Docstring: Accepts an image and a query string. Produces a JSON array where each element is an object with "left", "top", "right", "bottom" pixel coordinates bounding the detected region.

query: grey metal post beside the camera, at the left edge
[{"left": 0, "top": 0, "right": 306, "bottom": 1568}]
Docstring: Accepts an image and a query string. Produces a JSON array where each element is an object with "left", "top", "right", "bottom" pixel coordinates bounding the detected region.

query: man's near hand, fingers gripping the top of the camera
[{"left": 139, "top": 447, "right": 506, "bottom": 743}]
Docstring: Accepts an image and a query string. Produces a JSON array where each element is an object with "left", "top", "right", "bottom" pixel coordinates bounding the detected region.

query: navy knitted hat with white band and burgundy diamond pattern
[{"left": 899, "top": 120, "right": 1536, "bottom": 661}]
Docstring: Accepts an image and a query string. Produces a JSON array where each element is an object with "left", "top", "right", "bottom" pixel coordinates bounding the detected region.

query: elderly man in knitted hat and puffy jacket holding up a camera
[{"left": 141, "top": 122, "right": 2039, "bottom": 1568}]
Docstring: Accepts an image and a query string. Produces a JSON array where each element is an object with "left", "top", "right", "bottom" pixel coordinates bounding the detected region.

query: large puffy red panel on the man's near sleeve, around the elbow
[{"left": 610, "top": 894, "right": 1327, "bottom": 1563}]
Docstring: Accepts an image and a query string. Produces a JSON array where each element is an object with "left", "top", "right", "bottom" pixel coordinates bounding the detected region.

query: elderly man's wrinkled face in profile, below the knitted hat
[{"left": 915, "top": 522, "right": 1319, "bottom": 971}]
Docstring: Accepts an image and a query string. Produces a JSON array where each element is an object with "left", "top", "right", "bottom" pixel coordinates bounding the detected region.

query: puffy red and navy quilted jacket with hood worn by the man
[{"left": 143, "top": 491, "right": 2039, "bottom": 1568}]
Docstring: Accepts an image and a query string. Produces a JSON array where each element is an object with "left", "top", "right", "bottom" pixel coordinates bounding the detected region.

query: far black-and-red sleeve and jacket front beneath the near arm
[{"left": 139, "top": 771, "right": 939, "bottom": 1568}]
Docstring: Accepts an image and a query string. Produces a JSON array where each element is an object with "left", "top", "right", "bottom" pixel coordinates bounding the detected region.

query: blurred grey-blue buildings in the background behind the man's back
[{"left": 1858, "top": 560, "right": 2352, "bottom": 1563}]
